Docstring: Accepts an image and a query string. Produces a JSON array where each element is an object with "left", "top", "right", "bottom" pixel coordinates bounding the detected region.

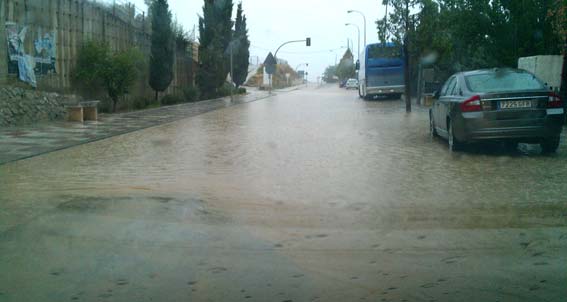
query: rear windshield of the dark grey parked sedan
[{"left": 465, "top": 72, "right": 545, "bottom": 92}]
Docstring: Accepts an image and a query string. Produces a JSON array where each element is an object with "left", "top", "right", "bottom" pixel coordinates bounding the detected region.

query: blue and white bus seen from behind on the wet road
[{"left": 358, "top": 42, "right": 405, "bottom": 99}]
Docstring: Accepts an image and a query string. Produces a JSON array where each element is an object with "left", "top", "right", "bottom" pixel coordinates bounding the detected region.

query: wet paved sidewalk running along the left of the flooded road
[{"left": 0, "top": 87, "right": 298, "bottom": 165}]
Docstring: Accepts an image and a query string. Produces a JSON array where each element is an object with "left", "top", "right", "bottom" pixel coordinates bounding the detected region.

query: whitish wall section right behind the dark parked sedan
[{"left": 518, "top": 56, "right": 563, "bottom": 91}]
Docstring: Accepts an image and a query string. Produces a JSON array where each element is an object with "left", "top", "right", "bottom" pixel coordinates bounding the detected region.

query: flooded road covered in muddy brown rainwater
[{"left": 0, "top": 86, "right": 567, "bottom": 302}]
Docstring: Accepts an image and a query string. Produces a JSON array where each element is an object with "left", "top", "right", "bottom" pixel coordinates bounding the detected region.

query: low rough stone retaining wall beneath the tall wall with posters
[{"left": 0, "top": 87, "right": 66, "bottom": 127}]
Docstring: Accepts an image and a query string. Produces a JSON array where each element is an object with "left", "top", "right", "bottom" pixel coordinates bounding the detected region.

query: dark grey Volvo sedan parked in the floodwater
[{"left": 429, "top": 69, "right": 565, "bottom": 153}]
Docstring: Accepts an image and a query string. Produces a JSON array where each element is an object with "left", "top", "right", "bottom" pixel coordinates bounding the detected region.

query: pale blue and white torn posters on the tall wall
[{"left": 6, "top": 22, "right": 57, "bottom": 87}]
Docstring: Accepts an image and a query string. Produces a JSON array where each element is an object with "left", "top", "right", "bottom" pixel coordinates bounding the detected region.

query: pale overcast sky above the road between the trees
[{"left": 123, "top": 0, "right": 384, "bottom": 81}]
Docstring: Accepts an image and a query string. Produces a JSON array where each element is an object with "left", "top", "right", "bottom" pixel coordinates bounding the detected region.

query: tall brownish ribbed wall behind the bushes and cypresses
[{"left": 0, "top": 0, "right": 193, "bottom": 96}]
